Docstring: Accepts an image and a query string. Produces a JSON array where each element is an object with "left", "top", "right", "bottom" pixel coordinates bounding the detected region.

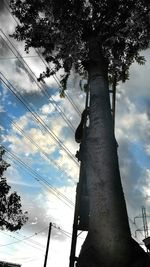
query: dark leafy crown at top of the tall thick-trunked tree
[{"left": 10, "top": 0, "right": 150, "bottom": 94}]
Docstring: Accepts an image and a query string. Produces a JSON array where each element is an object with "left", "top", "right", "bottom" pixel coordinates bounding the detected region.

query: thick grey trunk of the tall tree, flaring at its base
[{"left": 77, "top": 41, "right": 149, "bottom": 267}]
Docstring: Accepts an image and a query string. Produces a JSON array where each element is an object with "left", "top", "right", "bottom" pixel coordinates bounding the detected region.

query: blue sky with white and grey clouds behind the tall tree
[{"left": 0, "top": 0, "right": 150, "bottom": 267}]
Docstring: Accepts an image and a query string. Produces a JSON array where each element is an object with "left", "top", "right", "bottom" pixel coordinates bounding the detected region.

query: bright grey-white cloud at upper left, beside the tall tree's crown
[{"left": 0, "top": 32, "right": 56, "bottom": 94}]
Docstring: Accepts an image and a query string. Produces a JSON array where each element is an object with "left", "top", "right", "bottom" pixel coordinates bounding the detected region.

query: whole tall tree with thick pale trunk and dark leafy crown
[{"left": 10, "top": 0, "right": 150, "bottom": 267}]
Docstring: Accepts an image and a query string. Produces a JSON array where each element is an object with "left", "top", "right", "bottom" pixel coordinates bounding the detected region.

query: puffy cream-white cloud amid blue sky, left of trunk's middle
[{"left": 3, "top": 89, "right": 78, "bottom": 183}]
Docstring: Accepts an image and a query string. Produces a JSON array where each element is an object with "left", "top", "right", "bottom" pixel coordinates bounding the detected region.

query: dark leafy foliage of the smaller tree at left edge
[{"left": 0, "top": 148, "right": 28, "bottom": 231}]
